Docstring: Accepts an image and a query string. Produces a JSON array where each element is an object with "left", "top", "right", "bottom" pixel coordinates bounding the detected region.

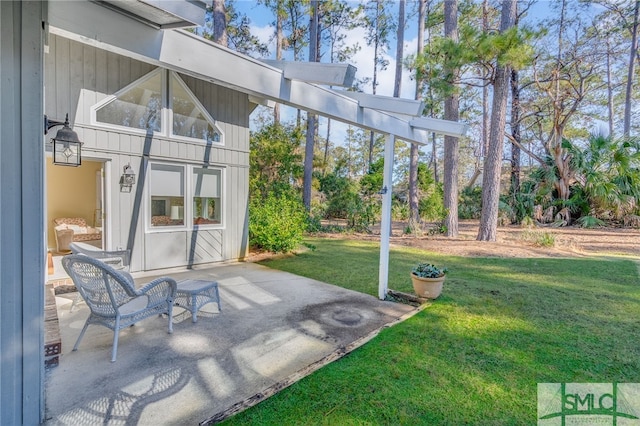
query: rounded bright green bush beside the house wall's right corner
[{"left": 249, "top": 193, "right": 308, "bottom": 253}]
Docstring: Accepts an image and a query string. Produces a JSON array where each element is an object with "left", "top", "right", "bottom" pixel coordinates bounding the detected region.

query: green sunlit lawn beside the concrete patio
[{"left": 221, "top": 239, "right": 640, "bottom": 425}]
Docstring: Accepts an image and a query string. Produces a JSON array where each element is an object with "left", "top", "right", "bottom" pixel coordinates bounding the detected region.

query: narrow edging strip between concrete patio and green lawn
[{"left": 199, "top": 304, "right": 429, "bottom": 426}]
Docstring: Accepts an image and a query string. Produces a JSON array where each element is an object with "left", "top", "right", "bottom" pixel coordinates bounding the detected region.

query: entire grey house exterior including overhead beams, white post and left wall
[{"left": 0, "top": 0, "right": 464, "bottom": 425}]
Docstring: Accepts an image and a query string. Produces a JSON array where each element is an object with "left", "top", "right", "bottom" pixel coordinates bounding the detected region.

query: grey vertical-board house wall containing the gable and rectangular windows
[{"left": 44, "top": 34, "right": 250, "bottom": 271}]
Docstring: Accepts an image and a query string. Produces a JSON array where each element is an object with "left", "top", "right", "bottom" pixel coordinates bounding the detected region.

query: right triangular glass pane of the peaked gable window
[{"left": 171, "top": 74, "right": 220, "bottom": 142}]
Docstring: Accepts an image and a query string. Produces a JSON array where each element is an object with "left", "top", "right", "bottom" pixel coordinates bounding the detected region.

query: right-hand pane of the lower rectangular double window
[{"left": 192, "top": 168, "right": 222, "bottom": 225}]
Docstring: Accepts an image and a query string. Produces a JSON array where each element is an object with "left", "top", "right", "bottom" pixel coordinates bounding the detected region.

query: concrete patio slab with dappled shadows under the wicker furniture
[{"left": 46, "top": 263, "right": 415, "bottom": 425}]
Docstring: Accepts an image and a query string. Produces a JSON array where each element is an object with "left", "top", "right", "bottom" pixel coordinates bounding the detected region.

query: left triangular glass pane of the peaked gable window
[{"left": 96, "top": 72, "right": 162, "bottom": 131}]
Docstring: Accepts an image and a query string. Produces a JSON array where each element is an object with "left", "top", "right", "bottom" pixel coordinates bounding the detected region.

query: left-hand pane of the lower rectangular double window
[{"left": 149, "top": 164, "right": 185, "bottom": 227}]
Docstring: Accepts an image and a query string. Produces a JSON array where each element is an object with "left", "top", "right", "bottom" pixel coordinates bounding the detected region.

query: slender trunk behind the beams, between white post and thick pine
[{"left": 409, "top": 0, "right": 427, "bottom": 232}]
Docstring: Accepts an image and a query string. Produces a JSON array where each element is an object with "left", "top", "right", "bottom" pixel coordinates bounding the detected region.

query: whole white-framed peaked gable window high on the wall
[{"left": 91, "top": 69, "right": 222, "bottom": 144}]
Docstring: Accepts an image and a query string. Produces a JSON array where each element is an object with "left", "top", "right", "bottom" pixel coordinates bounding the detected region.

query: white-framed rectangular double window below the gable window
[{"left": 148, "top": 162, "right": 224, "bottom": 231}]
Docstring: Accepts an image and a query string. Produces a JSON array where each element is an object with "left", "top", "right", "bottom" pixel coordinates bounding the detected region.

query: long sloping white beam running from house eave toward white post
[{"left": 49, "top": 1, "right": 429, "bottom": 144}]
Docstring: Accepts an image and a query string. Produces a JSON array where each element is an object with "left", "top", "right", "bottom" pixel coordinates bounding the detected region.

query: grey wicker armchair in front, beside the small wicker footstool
[{"left": 62, "top": 254, "right": 176, "bottom": 362}]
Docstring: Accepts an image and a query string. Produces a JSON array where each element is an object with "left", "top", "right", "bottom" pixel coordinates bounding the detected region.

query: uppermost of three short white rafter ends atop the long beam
[{"left": 261, "top": 59, "right": 357, "bottom": 87}]
